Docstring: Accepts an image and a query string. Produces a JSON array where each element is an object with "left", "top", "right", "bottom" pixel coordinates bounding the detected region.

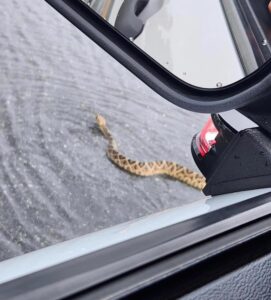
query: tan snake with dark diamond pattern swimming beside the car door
[{"left": 96, "top": 114, "right": 206, "bottom": 190}]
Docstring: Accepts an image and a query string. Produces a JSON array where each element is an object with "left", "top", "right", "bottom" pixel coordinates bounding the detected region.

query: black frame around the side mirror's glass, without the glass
[{"left": 45, "top": 0, "right": 271, "bottom": 129}]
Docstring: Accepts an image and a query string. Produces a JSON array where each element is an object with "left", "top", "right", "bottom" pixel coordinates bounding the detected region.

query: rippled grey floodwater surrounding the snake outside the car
[{"left": 0, "top": 0, "right": 207, "bottom": 260}]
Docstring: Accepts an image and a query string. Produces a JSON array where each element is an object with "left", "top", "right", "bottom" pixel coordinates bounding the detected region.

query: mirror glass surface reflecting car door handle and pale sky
[{"left": 80, "top": 0, "right": 271, "bottom": 88}]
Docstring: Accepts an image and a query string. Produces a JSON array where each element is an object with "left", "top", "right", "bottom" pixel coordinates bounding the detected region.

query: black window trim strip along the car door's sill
[{"left": 0, "top": 193, "right": 271, "bottom": 300}]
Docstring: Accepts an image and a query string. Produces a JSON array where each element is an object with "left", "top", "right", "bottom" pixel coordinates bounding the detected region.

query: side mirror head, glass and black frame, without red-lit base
[{"left": 46, "top": 0, "right": 271, "bottom": 132}]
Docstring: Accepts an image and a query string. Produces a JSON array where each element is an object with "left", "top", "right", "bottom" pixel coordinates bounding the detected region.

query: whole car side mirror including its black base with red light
[{"left": 46, "top": 0, "right": 271, "bottom": 195}]
